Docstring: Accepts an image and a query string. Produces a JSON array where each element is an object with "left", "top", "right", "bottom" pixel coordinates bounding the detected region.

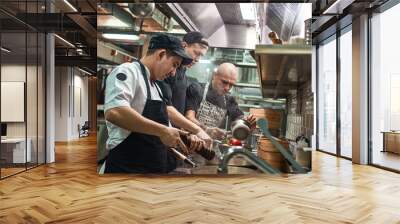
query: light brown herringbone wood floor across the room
[{"left": 0, "top": 134, "right": 400, "bottom": 224}]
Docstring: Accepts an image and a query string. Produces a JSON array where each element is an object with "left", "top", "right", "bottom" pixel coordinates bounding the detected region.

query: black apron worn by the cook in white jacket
[{"left": 105, "top": 61, "right": 176, "bottom": 173}]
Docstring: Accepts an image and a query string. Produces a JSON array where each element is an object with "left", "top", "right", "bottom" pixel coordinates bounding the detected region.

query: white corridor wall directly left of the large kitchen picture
[{"left": 55, "top": 67, "right": 88, "bottom": 141}]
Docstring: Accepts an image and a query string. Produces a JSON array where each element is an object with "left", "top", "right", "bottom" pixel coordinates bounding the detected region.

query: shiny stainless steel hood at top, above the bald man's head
[{"left": 167, "top": 3, "right": 258, "bottom": 49}]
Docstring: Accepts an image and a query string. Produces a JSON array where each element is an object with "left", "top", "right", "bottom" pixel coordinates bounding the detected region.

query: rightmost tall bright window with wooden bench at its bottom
[{"left": 370, "top": 1, "right": 400, "bottom": 170}]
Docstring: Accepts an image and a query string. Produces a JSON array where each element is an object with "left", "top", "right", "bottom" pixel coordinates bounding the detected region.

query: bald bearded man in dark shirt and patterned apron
[{"left": 185, "top": 63, "right": 255, "bottom": 138}]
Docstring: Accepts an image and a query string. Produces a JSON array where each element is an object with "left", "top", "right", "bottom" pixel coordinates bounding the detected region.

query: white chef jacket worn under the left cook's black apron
[{"left": 104, "top": 62, "right": 166, "bottom": 150}]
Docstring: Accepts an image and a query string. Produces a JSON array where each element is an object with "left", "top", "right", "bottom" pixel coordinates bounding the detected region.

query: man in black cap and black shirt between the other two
[{"left": 159, "top": 32, "right": 208, "bottom": 115}]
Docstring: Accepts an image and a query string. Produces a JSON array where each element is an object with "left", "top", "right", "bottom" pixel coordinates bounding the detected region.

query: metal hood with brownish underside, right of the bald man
[{"left": 255, "top": 45, "right": 312, "bottom": 99}]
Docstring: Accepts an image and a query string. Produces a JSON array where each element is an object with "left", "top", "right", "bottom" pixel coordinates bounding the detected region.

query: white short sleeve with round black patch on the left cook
[{"left": 104, "top": 66, "right": 138, "bottom": 111}]
